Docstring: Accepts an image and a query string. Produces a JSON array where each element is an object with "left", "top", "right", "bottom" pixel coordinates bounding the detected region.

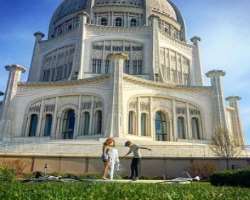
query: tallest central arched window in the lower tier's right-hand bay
[{"left": 155, "top": 111, "right": 167, "bottom": 141}]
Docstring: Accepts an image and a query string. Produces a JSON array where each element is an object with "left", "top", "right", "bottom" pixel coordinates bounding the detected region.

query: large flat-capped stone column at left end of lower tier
[{"left": 0, "top": 65, "right": 25, "bottom": 139}]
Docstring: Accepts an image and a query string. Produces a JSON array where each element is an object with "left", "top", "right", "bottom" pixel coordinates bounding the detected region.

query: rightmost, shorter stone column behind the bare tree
[{"left": 226, "top": 96, "right": 245, "bottom": 146}]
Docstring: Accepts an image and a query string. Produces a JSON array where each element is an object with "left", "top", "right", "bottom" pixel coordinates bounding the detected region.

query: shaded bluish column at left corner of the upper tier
[{"left": 28, "top": 32, "right": 45, "bottom": 82}]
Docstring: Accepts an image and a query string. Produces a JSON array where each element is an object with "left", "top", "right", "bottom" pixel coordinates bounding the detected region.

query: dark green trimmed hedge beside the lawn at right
[{"left": 210, "top": 168, "right": 250, "bottom": 187}]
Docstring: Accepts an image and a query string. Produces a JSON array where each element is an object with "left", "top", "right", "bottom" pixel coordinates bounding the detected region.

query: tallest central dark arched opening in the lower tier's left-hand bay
[{"left": 62, "top": 109, "right": 75, "bottom": 139}]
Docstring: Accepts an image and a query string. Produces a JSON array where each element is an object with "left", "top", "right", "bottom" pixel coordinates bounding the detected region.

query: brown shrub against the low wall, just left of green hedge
[{"left": 188, "top": 161, "right": 216, "bottom": 179}]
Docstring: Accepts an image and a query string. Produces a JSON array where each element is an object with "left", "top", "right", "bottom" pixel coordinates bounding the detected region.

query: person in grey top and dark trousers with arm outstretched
[{"left": 124, "top": 141, "right": 152, "bottom": 181}]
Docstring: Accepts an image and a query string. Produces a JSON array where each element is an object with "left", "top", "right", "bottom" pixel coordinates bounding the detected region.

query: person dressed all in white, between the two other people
[{"left": 108, "top": 144, "right": 120, "bottom": 180}]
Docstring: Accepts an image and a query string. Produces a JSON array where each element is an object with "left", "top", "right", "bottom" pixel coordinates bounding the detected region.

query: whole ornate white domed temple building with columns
[{"left": 0, "top": 0, "right": 244, "bottom": 175}]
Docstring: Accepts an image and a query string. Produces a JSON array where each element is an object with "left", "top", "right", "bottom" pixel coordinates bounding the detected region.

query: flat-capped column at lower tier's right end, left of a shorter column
[{"left": 206, "top": 70, "right": 227, "bottom": 128}]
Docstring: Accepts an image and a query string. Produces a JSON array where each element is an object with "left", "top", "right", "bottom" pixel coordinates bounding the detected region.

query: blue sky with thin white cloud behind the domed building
[{"left": 0, "top": 0, "right": 250, "bottom": 144}]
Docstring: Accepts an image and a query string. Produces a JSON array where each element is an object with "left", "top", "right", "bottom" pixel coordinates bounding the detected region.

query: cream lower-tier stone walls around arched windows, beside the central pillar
[{"left": 6, "top": 72, "right": 217, "bottom": 143}]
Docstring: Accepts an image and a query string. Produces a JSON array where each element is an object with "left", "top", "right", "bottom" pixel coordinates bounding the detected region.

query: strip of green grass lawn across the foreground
[{"left": 0, "top": 182, "right": 250, "bottom": 200}]
